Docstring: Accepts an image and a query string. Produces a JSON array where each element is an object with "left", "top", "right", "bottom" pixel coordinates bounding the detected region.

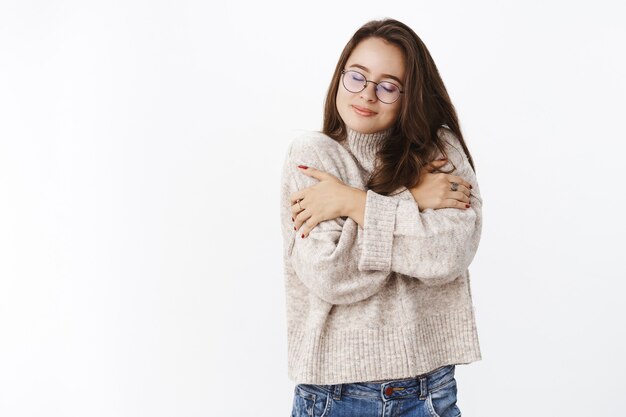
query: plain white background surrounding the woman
[{"left": 0, "top": 1, "right": 626, "bottom": 417}]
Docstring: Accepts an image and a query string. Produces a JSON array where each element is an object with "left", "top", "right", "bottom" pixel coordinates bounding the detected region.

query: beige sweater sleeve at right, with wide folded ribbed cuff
[{"left": 359, "top": 133, "right": 482, "bottom": 285}]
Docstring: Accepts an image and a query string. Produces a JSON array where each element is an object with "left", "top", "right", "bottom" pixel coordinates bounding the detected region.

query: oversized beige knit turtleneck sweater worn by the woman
[{"left": 280, "top": 127, "right": 482, "bottom": 384}]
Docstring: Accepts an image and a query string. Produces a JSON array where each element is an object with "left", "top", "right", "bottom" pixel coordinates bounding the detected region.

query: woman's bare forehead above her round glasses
[{"left": 346, "top": 38, "right": 404, "bottom": 80}]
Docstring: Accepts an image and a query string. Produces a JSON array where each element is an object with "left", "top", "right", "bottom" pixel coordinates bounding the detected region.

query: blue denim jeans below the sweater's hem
[{"left": 291, "top": 365, "right": 461, "bottom": 417}]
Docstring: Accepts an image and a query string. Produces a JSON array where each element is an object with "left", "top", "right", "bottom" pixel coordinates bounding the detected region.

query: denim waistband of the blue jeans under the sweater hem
[{"left": 296, "top": 365, "right": 455, "bottom": 400}]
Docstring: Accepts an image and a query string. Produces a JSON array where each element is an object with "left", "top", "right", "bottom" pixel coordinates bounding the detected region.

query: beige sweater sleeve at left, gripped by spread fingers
[{"left": 280, "top": 135, "right": 391, "bottom": 304}]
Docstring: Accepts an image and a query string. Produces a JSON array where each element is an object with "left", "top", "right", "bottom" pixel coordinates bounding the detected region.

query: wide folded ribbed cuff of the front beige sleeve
[{"left": 358, "top": 190, "right": 398, "bottom": 272}]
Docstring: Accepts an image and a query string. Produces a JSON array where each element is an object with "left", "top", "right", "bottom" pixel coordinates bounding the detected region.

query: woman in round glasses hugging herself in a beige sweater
[{"left": 281, "top": 19, "right": 482, "bottom": 417}]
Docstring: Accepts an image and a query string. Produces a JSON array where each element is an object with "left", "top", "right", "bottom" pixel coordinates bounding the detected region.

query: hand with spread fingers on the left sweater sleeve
[{"left": 289, "top": 166, "right": 352, "bottom": 238}]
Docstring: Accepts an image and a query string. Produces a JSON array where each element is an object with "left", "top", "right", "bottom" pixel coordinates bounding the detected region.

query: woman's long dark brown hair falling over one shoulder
[{"left": 322, "top": 19, "right": 475, "bottom": 195}]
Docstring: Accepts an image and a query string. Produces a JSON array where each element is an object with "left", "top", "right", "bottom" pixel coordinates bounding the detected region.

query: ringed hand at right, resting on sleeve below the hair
[{"left": 409, "top": 159, "right": 471, "bottom": 211}]
